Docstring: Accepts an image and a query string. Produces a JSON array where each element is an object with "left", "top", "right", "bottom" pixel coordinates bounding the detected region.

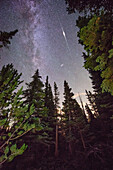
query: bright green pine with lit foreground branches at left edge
[{"left": 0, "top": 64, "right": 36, "bottom": 165}]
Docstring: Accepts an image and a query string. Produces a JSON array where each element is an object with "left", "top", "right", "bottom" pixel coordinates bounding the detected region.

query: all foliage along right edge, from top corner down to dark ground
[{"left": 63, "top": 0, "right": 113, "bottom": 170}]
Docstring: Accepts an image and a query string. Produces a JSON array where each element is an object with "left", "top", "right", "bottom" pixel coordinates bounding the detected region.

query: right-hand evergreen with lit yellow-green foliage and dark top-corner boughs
[{"left": 66, "top": 0, "right": 113, "bottom": 135}]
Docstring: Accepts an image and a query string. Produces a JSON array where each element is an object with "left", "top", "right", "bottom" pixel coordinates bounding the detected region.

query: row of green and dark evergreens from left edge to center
[{"left": 0, "top": 64, "right": 86, "bottom": 169}]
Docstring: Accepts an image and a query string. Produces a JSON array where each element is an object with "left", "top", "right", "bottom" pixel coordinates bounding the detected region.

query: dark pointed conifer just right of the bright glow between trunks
[{"left": 63, "top": 81, "right": 87, "bottom": 154}]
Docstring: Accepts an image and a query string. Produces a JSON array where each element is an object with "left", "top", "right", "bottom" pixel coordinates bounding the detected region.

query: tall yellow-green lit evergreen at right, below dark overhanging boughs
[{"left": 77, "top": 12, "right": 113, "bottom": 139}]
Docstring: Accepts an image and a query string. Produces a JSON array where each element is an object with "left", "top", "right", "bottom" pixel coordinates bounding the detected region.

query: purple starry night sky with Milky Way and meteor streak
[{"left": 0, "top": 0, "right": 92, "bottom": 106}]
